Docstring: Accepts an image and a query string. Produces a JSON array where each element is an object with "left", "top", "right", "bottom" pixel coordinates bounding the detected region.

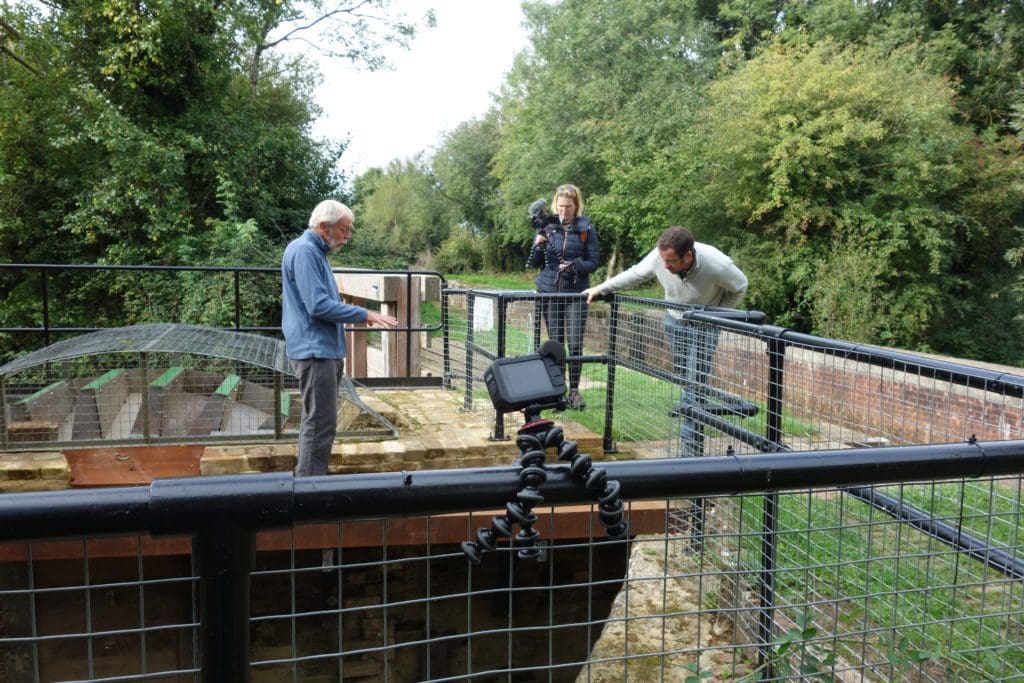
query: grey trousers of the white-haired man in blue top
[{"left": 292, "top": 358, "right": 343, "bottom": 477}]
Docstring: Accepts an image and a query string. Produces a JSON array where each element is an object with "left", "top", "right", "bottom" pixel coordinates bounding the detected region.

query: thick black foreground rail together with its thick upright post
[{"left": 0, "top": 440, "right": 1024, "bottom": 681}]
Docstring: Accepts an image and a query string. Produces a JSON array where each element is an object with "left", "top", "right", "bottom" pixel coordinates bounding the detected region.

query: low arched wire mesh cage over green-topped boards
[{"left": 0, "top": 324, "right": 396, "bottom": 450}]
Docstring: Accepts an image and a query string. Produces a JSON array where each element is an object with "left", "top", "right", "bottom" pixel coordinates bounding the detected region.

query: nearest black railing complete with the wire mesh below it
[{"left": 0, "top": 440, "right": 1024, "bottom": 681}]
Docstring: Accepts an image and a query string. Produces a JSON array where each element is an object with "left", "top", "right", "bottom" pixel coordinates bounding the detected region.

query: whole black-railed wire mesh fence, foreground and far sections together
[{"left": 0, "top": 291, "right": 1024, "bottom": 683}]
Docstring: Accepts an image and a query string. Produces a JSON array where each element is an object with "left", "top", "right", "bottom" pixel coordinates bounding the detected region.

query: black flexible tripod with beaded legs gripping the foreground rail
[{"left": 462, "top": 405, "right": 630, "bottom": 564}]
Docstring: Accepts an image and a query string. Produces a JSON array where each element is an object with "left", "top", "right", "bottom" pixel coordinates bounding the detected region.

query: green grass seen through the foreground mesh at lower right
[{"left": 716, "top": 489, "right": 1024, "bottom": 680}]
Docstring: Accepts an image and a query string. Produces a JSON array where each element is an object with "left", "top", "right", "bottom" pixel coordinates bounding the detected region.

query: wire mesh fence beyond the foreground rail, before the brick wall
[{"left": 445, "top": 290, "right": 1024, "bottom": 457}]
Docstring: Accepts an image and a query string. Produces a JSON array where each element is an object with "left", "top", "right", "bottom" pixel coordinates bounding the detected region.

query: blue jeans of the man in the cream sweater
[{"left": 665, "top": 312, "right": 718, "bottom": 458}]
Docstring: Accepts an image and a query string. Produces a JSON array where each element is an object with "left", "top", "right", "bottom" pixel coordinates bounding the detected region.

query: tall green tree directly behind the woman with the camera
[{"left": 494, "top": 0, "right": 717, "bottom": 272}]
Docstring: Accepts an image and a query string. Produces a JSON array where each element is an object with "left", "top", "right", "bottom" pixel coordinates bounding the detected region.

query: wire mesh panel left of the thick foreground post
[{"left": 0, "top": 536, "right": 200, "bottom": 683}]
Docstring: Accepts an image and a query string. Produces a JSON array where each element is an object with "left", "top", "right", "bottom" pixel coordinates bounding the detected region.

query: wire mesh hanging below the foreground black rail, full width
[{"left": 6, "top": 476, "right": 1024, "bottom": 681}]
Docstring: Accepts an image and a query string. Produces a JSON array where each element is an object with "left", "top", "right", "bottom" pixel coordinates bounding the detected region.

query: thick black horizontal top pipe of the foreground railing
[{"left": 0, "top": 440, "right": 1024, "bottom": 540}]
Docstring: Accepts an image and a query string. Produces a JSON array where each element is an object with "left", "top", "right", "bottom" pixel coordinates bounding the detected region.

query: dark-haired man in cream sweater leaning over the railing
[{"left": 583, "top": 225, "right": 746, "bottom": 456}]
